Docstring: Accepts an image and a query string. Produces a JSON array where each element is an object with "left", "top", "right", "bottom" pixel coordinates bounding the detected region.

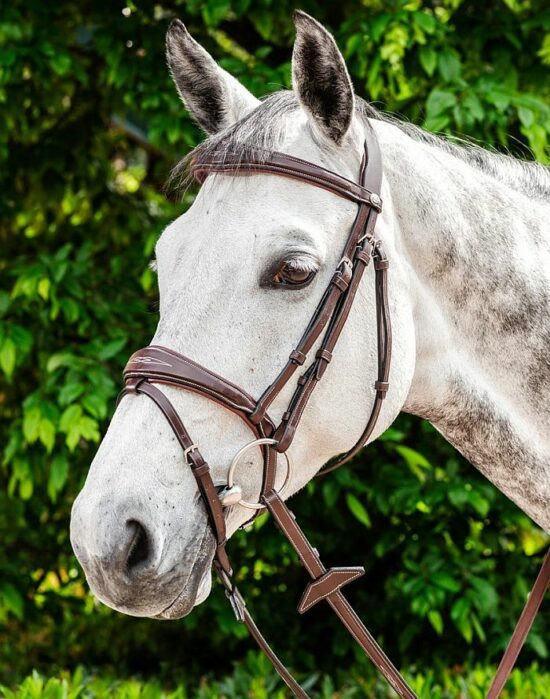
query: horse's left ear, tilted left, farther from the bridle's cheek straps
[{"left": 166, "top": 19, "right": 260, "bottom": 134}]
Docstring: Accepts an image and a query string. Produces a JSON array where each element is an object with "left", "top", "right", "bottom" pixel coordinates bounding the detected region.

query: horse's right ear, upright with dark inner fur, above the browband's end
[{"left": 292, "top": 10, "right": 355, "bottom": 144}]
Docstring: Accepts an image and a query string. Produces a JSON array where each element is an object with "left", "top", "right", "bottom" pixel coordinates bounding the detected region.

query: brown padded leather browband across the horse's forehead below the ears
[{"left": 191, "top": 151, "right": 382, "bottom": 212}]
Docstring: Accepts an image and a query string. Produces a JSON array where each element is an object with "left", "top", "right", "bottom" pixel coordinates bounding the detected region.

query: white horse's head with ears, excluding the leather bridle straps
[{"left": 71, "top": 13, "right": 415, "bottom": 618}]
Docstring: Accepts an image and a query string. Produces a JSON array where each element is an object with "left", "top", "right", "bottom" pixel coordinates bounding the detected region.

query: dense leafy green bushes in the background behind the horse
[{"left": 0, "top": 0, "right": 550, "bottom": 697}]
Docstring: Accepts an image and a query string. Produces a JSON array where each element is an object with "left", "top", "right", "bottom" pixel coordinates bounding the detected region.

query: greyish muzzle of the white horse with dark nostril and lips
[{"left": 71, "top": 497, "right": 215, "bottom": 619}]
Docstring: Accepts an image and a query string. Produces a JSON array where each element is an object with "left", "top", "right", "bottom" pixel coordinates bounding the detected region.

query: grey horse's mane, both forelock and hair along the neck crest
[{"left": 168, "top": 90, "right": 550, "bottom": 200}]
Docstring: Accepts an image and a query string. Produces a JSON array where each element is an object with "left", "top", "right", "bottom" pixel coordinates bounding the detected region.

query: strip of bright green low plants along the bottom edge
[{"left": 0, "top": 653, "right": 550, "bottom": 699}]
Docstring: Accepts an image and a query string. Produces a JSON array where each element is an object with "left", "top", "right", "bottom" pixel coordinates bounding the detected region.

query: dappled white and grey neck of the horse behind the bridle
[{"left": 377, "top": 119, "right": 550, "bottom": 531}]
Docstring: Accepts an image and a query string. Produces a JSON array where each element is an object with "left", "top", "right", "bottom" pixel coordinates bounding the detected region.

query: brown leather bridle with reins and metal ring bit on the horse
[{"left": 116, "top": 129, "right": 550, "bottom": 699}]
